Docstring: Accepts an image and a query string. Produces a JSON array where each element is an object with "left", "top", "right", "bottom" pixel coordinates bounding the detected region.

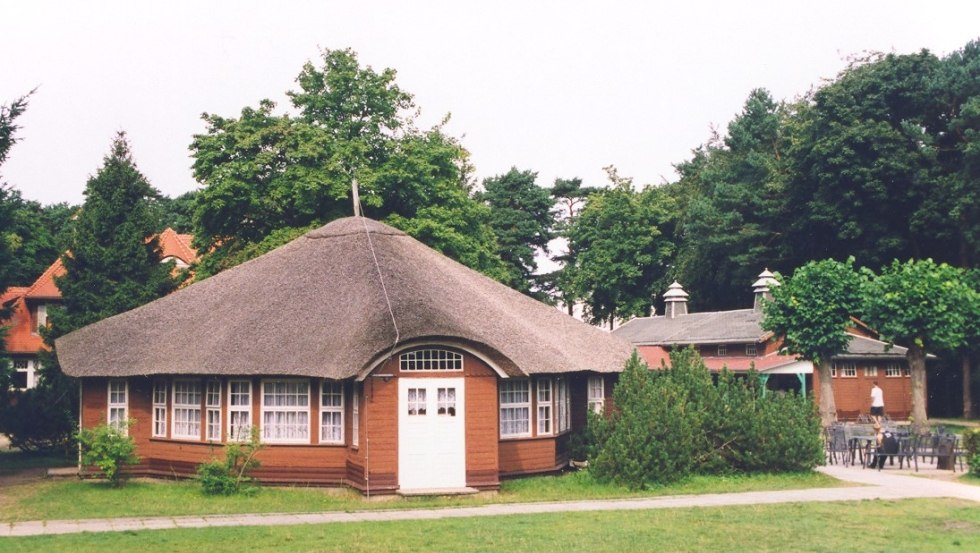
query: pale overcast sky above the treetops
[{"left": 0, "top": 0, "right": 980, "bottom": 203}]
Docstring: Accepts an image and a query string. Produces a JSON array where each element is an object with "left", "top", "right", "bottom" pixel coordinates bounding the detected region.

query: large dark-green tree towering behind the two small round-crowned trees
[{"left": 787, "top": 51, "right": 953, "bottom": 267}]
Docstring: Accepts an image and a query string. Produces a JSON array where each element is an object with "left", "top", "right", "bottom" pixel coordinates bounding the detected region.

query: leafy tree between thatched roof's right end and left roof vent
[{"left": 566, "top": 167, "right": 674, "bottom": 328}]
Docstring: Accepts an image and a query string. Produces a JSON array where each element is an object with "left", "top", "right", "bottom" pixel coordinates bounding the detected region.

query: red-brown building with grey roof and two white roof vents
[{"left": 613, "top": 270, "right": 912, "bottom": 420}]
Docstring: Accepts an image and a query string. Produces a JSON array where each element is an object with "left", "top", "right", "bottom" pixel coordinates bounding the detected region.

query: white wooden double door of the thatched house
[{"left": 398, "top": 378, "right": 466, "bottom": 490}]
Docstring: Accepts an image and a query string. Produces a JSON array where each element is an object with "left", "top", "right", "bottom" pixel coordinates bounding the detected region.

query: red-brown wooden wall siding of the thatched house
[{"left": 81, "top": 354, "right": 617, "bottom": 488}]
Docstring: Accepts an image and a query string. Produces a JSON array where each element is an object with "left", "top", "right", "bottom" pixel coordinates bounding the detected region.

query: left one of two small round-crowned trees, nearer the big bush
[{"left": 762, "top": 258, "right": 864, "bottom": 426}]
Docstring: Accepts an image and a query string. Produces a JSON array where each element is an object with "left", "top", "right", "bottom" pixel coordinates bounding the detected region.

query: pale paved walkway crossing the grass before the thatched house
[{"left": 0, "top": 465, "right": 980, "bottom": 537}]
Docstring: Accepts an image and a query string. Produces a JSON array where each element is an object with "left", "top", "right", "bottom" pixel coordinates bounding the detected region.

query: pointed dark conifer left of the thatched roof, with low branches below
[{"left": 11, "top": 132, "right": 176, "bottom": 449}]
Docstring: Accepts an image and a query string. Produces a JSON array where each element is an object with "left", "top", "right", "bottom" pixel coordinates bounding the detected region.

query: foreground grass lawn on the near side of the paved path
[{"left": 0, "top": 499, "right": 980, "bottom": 553}]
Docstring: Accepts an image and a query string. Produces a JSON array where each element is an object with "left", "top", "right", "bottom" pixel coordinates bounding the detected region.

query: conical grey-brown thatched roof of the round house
[{"left": 56, "top": 217, "right": 631, "bottom": 379}]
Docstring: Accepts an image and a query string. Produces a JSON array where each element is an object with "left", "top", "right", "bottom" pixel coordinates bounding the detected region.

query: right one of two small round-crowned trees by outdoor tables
[{"left": 862, "top": 259, "right": 980, "bottom": 427}]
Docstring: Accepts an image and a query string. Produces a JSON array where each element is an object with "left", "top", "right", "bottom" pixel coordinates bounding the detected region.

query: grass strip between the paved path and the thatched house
[{"left": 0, "top": 471, "right": 847, "bottom": 522}]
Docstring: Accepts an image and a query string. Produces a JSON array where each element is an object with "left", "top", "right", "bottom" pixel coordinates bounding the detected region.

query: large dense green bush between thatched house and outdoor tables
[{"left": 591, "top": 348, "right": 823, "bottom": 488}]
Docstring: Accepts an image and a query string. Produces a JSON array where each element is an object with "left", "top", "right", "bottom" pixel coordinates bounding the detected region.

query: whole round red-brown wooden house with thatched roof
[{"left": 57, "top": 217, "right": 631, "bottom": 494}]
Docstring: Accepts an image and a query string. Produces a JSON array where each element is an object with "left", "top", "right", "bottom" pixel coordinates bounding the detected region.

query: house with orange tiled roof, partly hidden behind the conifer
[{"left": 0, "top": 228, "right": 197, "bottom": 390}]
